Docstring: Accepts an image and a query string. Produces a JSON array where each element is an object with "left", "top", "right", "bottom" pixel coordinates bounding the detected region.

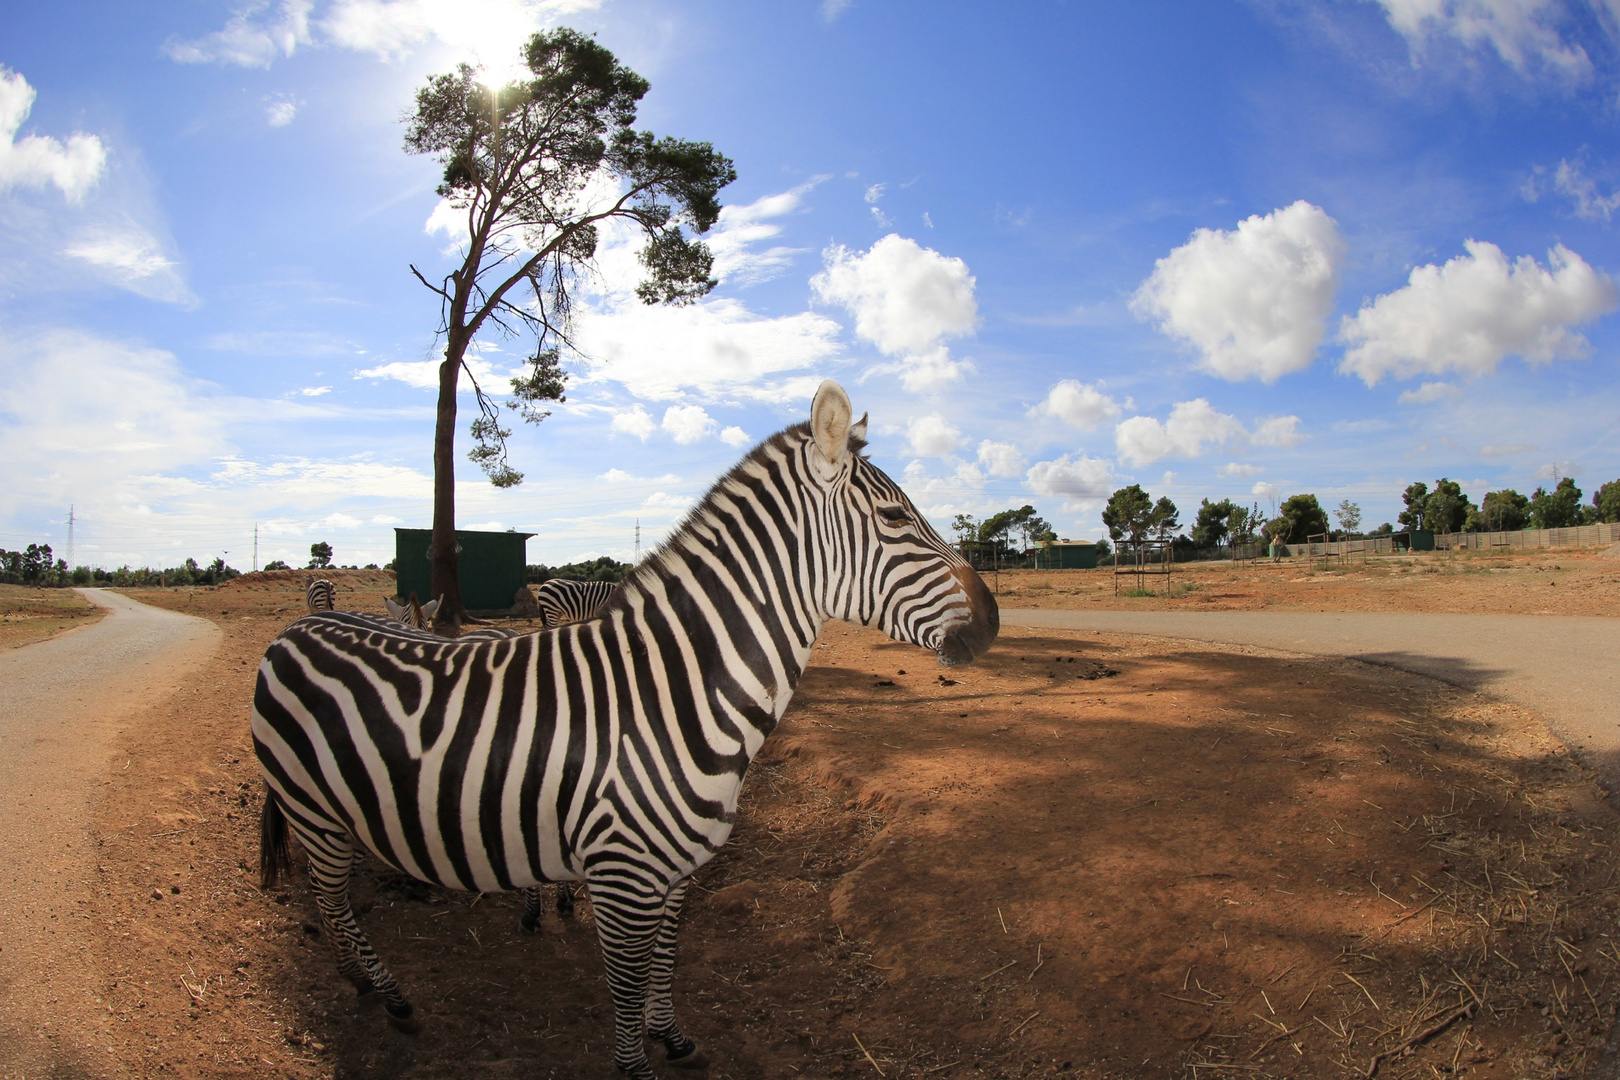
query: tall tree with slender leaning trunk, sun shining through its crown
[{"left": 405, "top": 29, "right": 735, "bottom": 623}]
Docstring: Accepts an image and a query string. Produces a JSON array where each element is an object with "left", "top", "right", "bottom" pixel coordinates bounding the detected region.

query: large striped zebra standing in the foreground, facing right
[{"left": 253, "top": 381, "right": 1000, "bottom": 1080}]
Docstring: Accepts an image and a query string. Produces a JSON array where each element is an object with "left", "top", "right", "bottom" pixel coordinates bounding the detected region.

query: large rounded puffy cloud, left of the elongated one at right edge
[{"left": 1131, "top": 199, "right": 1345, "bottom": 382}]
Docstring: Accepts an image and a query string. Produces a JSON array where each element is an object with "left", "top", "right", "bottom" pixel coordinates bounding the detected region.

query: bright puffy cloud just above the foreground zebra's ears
[{"left": 810, "top": 233, "right": 978, "bottom": 392}]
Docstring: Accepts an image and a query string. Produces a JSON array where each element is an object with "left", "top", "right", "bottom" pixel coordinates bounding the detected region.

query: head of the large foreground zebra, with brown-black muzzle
[{"left": 804, "top": 381, "right": 1001, "bottom": 665}]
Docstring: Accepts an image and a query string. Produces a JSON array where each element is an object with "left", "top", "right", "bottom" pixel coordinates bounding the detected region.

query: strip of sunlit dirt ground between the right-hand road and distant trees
[{"left": 985, "top": 547, "right": 1620, "bottom": 615}]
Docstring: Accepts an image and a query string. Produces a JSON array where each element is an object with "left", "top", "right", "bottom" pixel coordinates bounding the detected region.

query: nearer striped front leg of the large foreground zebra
[{"left": 588, "top": 868, "right": 697, "bottom": 1080}]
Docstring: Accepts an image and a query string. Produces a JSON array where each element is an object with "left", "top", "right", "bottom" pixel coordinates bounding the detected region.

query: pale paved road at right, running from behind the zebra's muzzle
[{"left": 1001, "top": 607, "right": 1620, "bottom": 790}]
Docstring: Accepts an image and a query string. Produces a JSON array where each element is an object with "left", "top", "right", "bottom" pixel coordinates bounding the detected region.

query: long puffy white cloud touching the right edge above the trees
[{"left": 1338, "top": 240, "right": 1617, "bottom": 387}]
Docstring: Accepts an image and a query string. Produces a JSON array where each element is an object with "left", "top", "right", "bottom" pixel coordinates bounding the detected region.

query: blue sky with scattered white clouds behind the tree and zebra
[{"left": 0, "top": 0, "right": 1620, "bottom": 568}]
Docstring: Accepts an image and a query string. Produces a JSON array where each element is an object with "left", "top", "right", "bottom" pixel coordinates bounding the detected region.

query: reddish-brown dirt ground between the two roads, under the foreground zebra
[{"left": 78, "top": 569, "right": 1620, "bottom": 1080}]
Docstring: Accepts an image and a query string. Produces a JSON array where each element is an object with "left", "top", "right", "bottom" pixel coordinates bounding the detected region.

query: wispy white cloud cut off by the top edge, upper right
[{"left": 1379, "top": 0, "right": 1592, "bottom": 83}]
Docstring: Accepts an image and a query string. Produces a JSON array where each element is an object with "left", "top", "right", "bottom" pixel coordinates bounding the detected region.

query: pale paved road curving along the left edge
[{"left": 0, "top": 589, "right": 220, "bottom": 1078}]
